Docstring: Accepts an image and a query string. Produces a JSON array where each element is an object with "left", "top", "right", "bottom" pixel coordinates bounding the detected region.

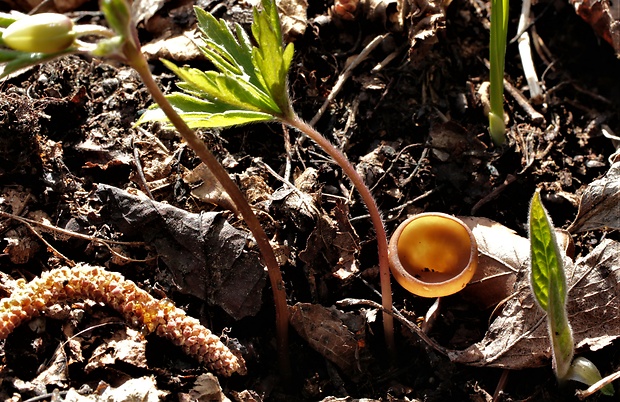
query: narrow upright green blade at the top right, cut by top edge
[{"left": 489, "top": 0, "right": 509, "bottom": 145}]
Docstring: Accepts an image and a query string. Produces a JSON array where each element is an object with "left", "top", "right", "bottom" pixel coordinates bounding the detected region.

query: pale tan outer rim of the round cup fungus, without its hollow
[{"left": 388, "top": 212, "right": 478, "bottom": 297}]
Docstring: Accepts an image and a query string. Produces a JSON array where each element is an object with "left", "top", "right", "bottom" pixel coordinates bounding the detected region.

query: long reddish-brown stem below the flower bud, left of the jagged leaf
[{"left": 124, "top": 41, "right": 290, "bottom": 378}]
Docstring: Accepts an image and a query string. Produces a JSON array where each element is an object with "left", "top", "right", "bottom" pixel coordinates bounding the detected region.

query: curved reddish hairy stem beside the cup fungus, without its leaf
[{"left": 281, "top": 114, "right": 396, "bottom": 357}]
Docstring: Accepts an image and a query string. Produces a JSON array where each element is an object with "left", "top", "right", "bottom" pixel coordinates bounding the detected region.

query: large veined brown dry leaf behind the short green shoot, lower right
[{"left": 448, "top": 239, "right": 620, "bottom": 370}]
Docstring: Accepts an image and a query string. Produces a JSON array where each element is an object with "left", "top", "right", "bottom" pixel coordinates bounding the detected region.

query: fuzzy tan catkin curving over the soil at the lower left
[{"left": 0, "top": 265, "right": 245, "bottom": 376}]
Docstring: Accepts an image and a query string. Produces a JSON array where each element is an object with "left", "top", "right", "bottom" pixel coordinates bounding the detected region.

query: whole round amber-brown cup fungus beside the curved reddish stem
[{"left": 389, "top": 212, "right": 478, "bottom": 297}]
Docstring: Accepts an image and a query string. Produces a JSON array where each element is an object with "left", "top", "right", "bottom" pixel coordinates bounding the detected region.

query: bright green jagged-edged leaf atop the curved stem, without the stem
[{"left": 154, "top": 0, "right": 294, "bottom": 127}]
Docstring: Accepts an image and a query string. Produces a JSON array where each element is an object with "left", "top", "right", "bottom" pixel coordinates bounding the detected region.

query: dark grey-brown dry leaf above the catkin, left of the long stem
[{"left": 96, "top": 184, "right": 266, "bottom": 319}]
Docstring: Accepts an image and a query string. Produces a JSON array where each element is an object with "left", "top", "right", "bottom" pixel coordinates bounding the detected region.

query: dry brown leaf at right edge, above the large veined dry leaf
[{"left": 568, "top": 162, "right": 620, "bottom": 233}]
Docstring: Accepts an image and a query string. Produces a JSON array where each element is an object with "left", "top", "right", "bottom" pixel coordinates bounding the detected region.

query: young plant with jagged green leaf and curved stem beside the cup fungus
[{"left": 139, "top": 0, "right": 394, "bottom": 351}]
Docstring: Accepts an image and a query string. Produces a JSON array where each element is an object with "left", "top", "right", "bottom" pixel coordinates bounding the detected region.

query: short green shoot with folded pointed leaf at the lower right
[{"left": 529, "top": 191, "right": 614, "bottom": 395}]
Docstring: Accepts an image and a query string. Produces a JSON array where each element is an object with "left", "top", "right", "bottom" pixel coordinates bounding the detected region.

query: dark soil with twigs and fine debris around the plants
[{"left": 0, "top": 0, "right": 620, "bottom": 401}]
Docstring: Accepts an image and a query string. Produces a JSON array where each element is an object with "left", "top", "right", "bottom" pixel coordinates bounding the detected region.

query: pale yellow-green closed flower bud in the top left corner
[{"left": 2, "top": 13, "right": 76, "bottom": 53}]
